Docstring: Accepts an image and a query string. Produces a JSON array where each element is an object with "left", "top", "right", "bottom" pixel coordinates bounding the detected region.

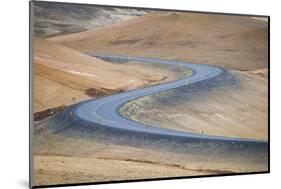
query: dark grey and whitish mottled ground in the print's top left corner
[{"left": 33, "top": 2, "right": 148, "bottom": 37}]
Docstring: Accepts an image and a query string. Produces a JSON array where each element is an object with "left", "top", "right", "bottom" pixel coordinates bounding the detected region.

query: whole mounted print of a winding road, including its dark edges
[{"left": 29, "top": 1, "right": 270, "bottom": 188}]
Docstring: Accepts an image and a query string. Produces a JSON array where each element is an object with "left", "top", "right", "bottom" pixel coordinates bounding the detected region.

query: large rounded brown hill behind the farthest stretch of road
[{"left": 50, "top": 12, "right": 268, "bottom": 70}]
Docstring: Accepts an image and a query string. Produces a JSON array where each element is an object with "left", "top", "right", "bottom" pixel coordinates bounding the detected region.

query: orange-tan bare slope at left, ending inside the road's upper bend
[{"left": 34, "top": 38, "right": 182, "bottom": 112}]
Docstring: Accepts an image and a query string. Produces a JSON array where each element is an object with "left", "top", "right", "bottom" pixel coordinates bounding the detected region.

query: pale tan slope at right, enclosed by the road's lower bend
[{"left": 121, "top": 70, "right": 268, "bottom": 140}]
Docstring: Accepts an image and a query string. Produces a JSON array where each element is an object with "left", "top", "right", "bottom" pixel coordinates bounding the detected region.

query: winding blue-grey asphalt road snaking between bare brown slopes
[{"left": 63, "top": 53, "right": 267, "bottom": 144}]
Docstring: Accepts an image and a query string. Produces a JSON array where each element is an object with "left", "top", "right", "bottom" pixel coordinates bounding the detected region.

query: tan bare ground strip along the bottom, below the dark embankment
[{"left": 34, "top": 134, "right": 267, "bottom": 185}]
